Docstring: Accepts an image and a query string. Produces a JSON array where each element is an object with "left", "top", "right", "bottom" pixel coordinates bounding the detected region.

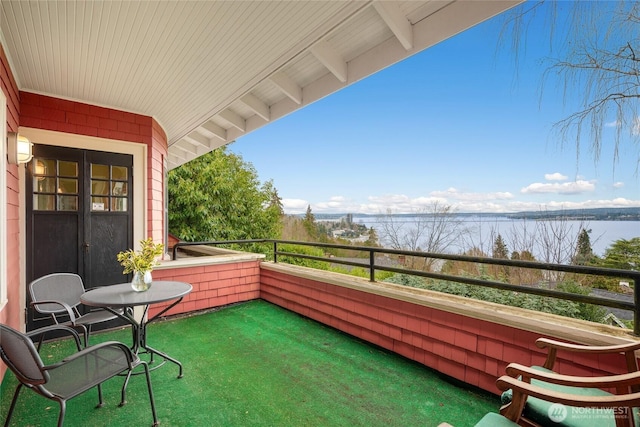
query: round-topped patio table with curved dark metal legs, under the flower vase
[{"left": 80, "top": 280, "right": 192, "bottom": 379}]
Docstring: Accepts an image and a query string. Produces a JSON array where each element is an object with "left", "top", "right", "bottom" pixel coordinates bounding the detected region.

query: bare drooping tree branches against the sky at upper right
[{"left": 502, "top": 0, "right": 640, "bottom": 171}]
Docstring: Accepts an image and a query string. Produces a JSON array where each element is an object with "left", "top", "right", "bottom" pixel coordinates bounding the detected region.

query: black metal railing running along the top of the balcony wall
[{"left": 172, "top": 239, "right": 640, "bottom": 335}]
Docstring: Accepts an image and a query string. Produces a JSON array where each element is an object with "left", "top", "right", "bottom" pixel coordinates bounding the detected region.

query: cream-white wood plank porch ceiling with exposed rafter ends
[{"left": 0, "top": 0, "right": 522, "bottom": 169}]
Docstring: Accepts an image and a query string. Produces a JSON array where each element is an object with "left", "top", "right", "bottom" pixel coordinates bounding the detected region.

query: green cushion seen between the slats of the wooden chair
[{"left": 501, "top": 366, "right": 640, "bottom": 427}]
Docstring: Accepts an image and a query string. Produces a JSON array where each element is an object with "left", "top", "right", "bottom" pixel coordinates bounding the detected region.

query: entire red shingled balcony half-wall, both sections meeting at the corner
[{"left": 104, "top": 259, "right": 626, "bottom": 393}]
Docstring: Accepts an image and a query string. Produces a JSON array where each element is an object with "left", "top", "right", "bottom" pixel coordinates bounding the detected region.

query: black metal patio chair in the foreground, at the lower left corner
[{"left": 0, "top": 324, "right": 158, "bottom": 427}]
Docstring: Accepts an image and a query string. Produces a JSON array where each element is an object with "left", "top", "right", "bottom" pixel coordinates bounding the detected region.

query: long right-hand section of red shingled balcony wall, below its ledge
[{"left": 260, "top": 268, "right": 626, "bottom": 393}]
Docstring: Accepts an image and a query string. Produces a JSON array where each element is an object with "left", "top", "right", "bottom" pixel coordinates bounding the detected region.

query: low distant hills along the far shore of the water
[{"left": 312, "top": 207, "right": 640, "bottom": 221}]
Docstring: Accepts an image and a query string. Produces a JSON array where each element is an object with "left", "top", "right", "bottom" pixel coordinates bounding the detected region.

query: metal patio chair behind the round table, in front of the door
[{"left": 29, "top": 273, "right": 125, "bottom": 348}]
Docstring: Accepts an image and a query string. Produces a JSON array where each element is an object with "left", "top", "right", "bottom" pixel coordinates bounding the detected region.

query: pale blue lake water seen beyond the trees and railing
[{"left": 353, "top": 215, "right": 640, "bottom": 256}]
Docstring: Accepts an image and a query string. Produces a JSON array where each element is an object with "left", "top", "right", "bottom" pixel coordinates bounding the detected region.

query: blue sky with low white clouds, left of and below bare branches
[{"left": 229, "top": 2, "right": 640, "bottom": 214}]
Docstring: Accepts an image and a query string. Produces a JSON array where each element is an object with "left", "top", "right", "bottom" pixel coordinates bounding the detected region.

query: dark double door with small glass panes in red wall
[{"left": 26, "top": 144, "right": 133, "bottom": 330}]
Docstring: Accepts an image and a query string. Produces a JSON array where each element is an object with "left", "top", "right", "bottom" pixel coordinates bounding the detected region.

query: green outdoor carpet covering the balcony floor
[{"left": 0, "top": 300, "right": 499, "bottom": 427}]
